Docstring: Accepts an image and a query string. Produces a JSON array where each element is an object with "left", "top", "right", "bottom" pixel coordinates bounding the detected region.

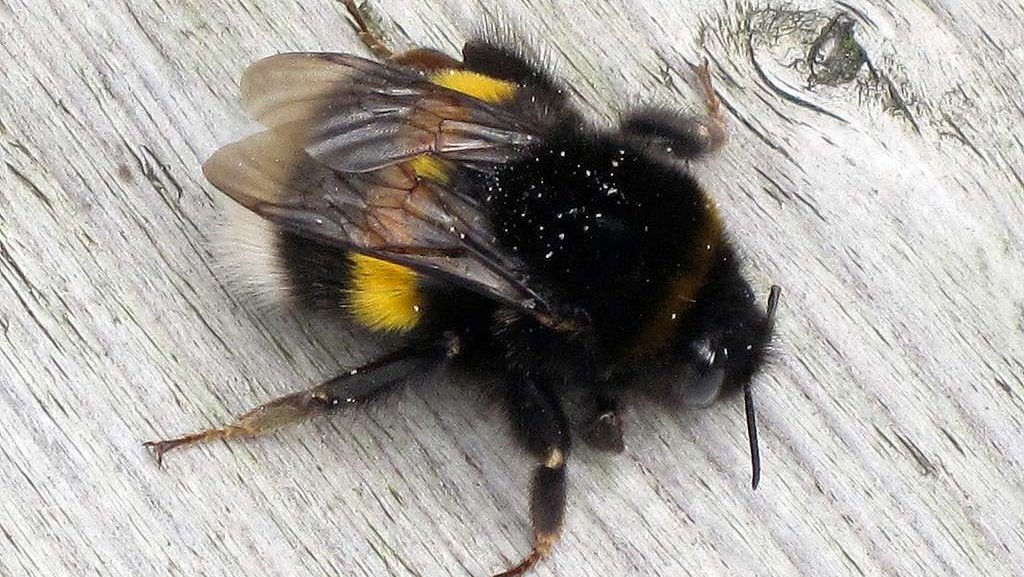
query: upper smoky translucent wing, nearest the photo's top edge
[{"left": 236, "top": 52, "right": 539, "bottom": 173}]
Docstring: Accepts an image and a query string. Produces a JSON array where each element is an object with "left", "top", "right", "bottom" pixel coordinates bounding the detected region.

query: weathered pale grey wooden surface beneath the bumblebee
[{"left": 0, "top": 0, "right": 1024, "bottom": 577}]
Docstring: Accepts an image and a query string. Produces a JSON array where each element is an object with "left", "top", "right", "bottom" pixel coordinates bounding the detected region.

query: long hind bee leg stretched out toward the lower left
[{"left": 143, "top": 345, "right": 438, "bottom": 464}]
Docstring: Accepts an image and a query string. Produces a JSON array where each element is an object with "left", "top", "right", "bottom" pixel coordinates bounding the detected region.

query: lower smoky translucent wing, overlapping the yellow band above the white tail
[{"left": 203, "top": 130, "right": 558, "bottom": 324}]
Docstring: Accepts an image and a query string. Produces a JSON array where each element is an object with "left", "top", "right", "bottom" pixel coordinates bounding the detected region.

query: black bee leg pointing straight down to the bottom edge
[{"left": 494, "top": 378, "right": 570, "bottom": 577}]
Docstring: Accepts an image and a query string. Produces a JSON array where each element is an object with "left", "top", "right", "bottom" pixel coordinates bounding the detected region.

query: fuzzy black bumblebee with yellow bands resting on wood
[{"left": 147, "top": 0, "right": 778, "bottom": 576}]
